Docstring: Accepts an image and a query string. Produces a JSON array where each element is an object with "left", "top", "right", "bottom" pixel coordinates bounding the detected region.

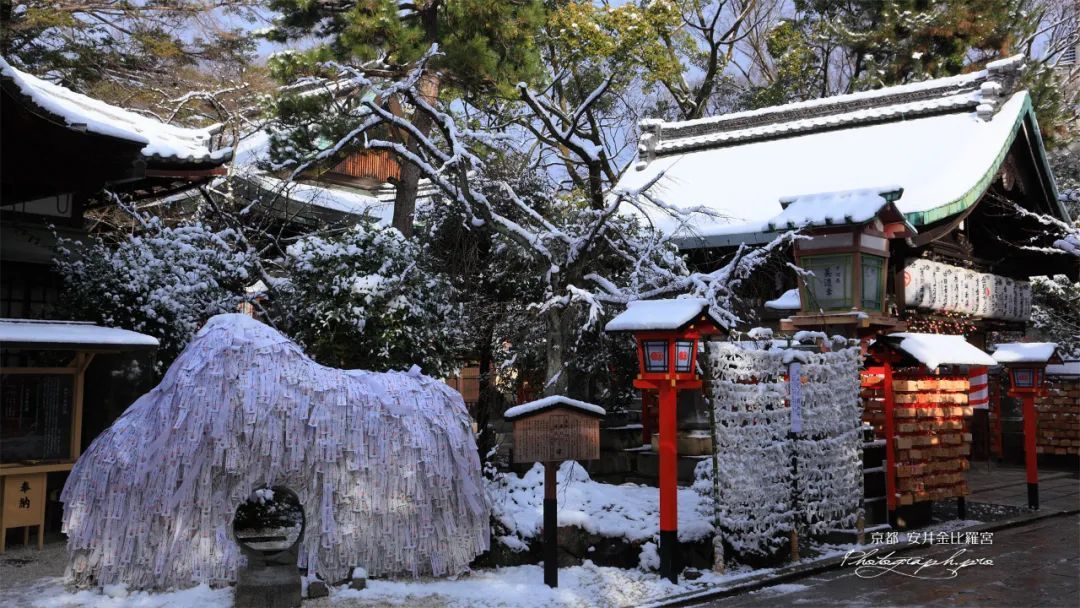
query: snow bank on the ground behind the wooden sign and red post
[{"left": 488, "top": 461, "right": 713, "bottom": 548}]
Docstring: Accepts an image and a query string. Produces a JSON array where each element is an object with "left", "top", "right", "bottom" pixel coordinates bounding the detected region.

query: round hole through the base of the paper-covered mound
[{"left": 232, "top": 486, "right": 305, "bottom": 555}]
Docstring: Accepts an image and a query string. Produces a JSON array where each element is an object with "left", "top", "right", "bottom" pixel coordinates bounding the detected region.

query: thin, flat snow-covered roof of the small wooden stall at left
[{"left": 0, "top": 319, "right": 158, "bottom": 350}]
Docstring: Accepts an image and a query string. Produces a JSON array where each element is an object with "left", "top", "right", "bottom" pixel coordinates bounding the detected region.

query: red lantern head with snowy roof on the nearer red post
[{"left": 604, "top": 298, "right": 721, "bottom": 384}]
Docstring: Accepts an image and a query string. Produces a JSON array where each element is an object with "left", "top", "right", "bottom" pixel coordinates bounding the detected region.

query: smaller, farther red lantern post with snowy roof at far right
[{"left": 994, "top": 342, "right": 1062, "bottom": 510}]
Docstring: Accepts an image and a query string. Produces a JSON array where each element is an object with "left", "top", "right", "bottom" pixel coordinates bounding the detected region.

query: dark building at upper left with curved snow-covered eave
[{"left": 0, "top": 58, "right": 232, "bottom": 319}]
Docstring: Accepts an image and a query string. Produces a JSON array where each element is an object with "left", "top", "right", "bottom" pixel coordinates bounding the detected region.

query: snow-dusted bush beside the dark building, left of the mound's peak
[{"left": 56, "top": 217, "right": 254, "bottom": 365}]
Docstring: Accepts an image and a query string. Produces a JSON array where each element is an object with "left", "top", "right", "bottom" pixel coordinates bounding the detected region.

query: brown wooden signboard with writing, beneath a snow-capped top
[{"left": 514, "top": 407, "right": 600, "bottom": 462}]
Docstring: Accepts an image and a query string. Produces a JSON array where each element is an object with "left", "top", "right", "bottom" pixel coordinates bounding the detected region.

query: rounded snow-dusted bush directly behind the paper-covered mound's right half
[{"left": 272, "top": 226, "right": 462, "bottom": 376}]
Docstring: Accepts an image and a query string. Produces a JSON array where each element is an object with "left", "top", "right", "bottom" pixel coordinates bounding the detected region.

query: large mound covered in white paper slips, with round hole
[{"left": 62, "top": 314, "right": 489, "bottom": 589}]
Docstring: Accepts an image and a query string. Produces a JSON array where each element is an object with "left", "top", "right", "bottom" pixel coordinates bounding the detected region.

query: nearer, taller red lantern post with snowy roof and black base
[{"left": 605, "top": 298, "right": 721, "bottom": 582}]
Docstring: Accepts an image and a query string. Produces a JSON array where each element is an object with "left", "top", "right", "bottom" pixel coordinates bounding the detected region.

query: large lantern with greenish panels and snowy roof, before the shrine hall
[{"left": 767, "top": 187, "right": 915, "bottom": 314}]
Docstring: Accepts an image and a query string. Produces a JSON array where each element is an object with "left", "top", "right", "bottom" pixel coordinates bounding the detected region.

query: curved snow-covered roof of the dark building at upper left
[{"left": 0, "top": 57, "right": 232, "bottom": 164}]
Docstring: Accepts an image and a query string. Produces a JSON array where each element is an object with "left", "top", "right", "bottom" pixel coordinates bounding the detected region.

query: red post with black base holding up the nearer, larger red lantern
[{"left": 660, "top": 380, "right": 678, "bottom": 582}]
